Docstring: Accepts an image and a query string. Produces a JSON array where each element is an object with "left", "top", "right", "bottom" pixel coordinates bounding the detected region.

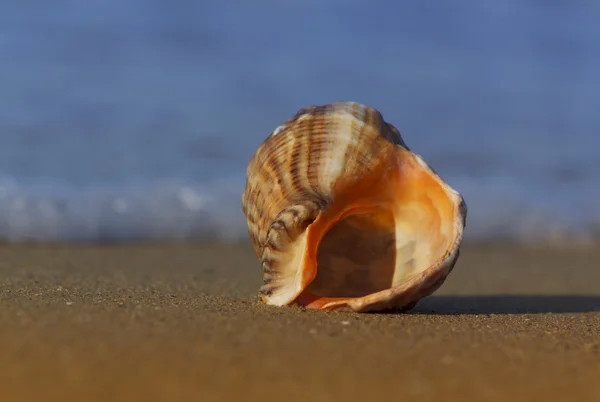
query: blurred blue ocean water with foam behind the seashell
[{"left": 0, "top": 0, "right": 600, "bottom": 242}]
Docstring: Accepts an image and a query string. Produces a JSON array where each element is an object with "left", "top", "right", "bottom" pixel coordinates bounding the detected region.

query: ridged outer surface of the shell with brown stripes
[{"left": 242, "top": 102, "right": 408, "bottom": 302}]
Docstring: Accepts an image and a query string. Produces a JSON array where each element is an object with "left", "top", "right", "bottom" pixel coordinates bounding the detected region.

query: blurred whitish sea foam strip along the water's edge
[{"left": 0, "top": 177, "right": 600, "bottom": 243}]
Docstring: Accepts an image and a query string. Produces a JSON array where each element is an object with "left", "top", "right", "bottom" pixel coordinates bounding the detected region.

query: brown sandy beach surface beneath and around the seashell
[{"left": 0, "top": 243, "right": 600, "bottom": 402}]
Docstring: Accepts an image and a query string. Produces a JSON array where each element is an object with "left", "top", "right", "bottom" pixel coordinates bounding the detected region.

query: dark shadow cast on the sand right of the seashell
[{"left": 405, "top": 295, "right": 600, "bottom": 315}]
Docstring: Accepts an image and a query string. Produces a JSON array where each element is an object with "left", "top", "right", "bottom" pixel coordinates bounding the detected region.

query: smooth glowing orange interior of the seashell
[{"left": 291, "top": 147, "right": 459, "bottom": 309}]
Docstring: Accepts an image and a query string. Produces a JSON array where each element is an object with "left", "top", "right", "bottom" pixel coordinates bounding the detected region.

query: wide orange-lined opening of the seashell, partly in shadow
[{"left": 296, "top": 149, "right": 464, "bottom": 310}]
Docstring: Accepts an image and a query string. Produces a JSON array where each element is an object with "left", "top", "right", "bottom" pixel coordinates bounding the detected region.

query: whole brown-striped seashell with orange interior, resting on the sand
[{"left": 242, "top": 102, "right": 467, "bottom": 312}]
